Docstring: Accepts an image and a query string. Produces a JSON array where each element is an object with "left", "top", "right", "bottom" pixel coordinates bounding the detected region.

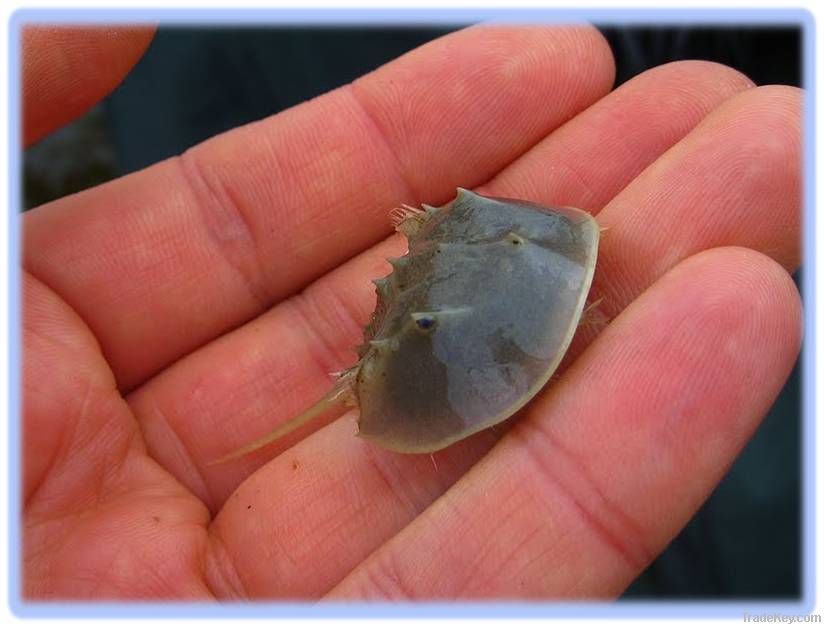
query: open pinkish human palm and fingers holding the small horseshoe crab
[{"left": 23, "top": 27, "right": 801, "bottom": 600}]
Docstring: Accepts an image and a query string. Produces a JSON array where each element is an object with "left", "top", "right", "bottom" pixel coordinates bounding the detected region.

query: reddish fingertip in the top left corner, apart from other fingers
[{"left": 22, "top": 26, "right": 155, "bottom": 145}]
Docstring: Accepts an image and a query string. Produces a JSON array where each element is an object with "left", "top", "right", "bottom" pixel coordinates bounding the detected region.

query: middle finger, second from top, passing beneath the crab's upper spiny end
[{"left": 130, "top": 57, "right": 749, "bottom": 508}]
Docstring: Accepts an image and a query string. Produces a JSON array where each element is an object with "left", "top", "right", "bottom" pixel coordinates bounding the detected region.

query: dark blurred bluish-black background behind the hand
[{"left": 24, "top": 26, "right": 801, "bottom": 600}]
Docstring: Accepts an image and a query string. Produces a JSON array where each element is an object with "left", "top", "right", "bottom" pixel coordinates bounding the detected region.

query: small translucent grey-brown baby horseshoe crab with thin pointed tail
[{"left": 212, "top": 188, "right": 600, "bottom": 462}]
